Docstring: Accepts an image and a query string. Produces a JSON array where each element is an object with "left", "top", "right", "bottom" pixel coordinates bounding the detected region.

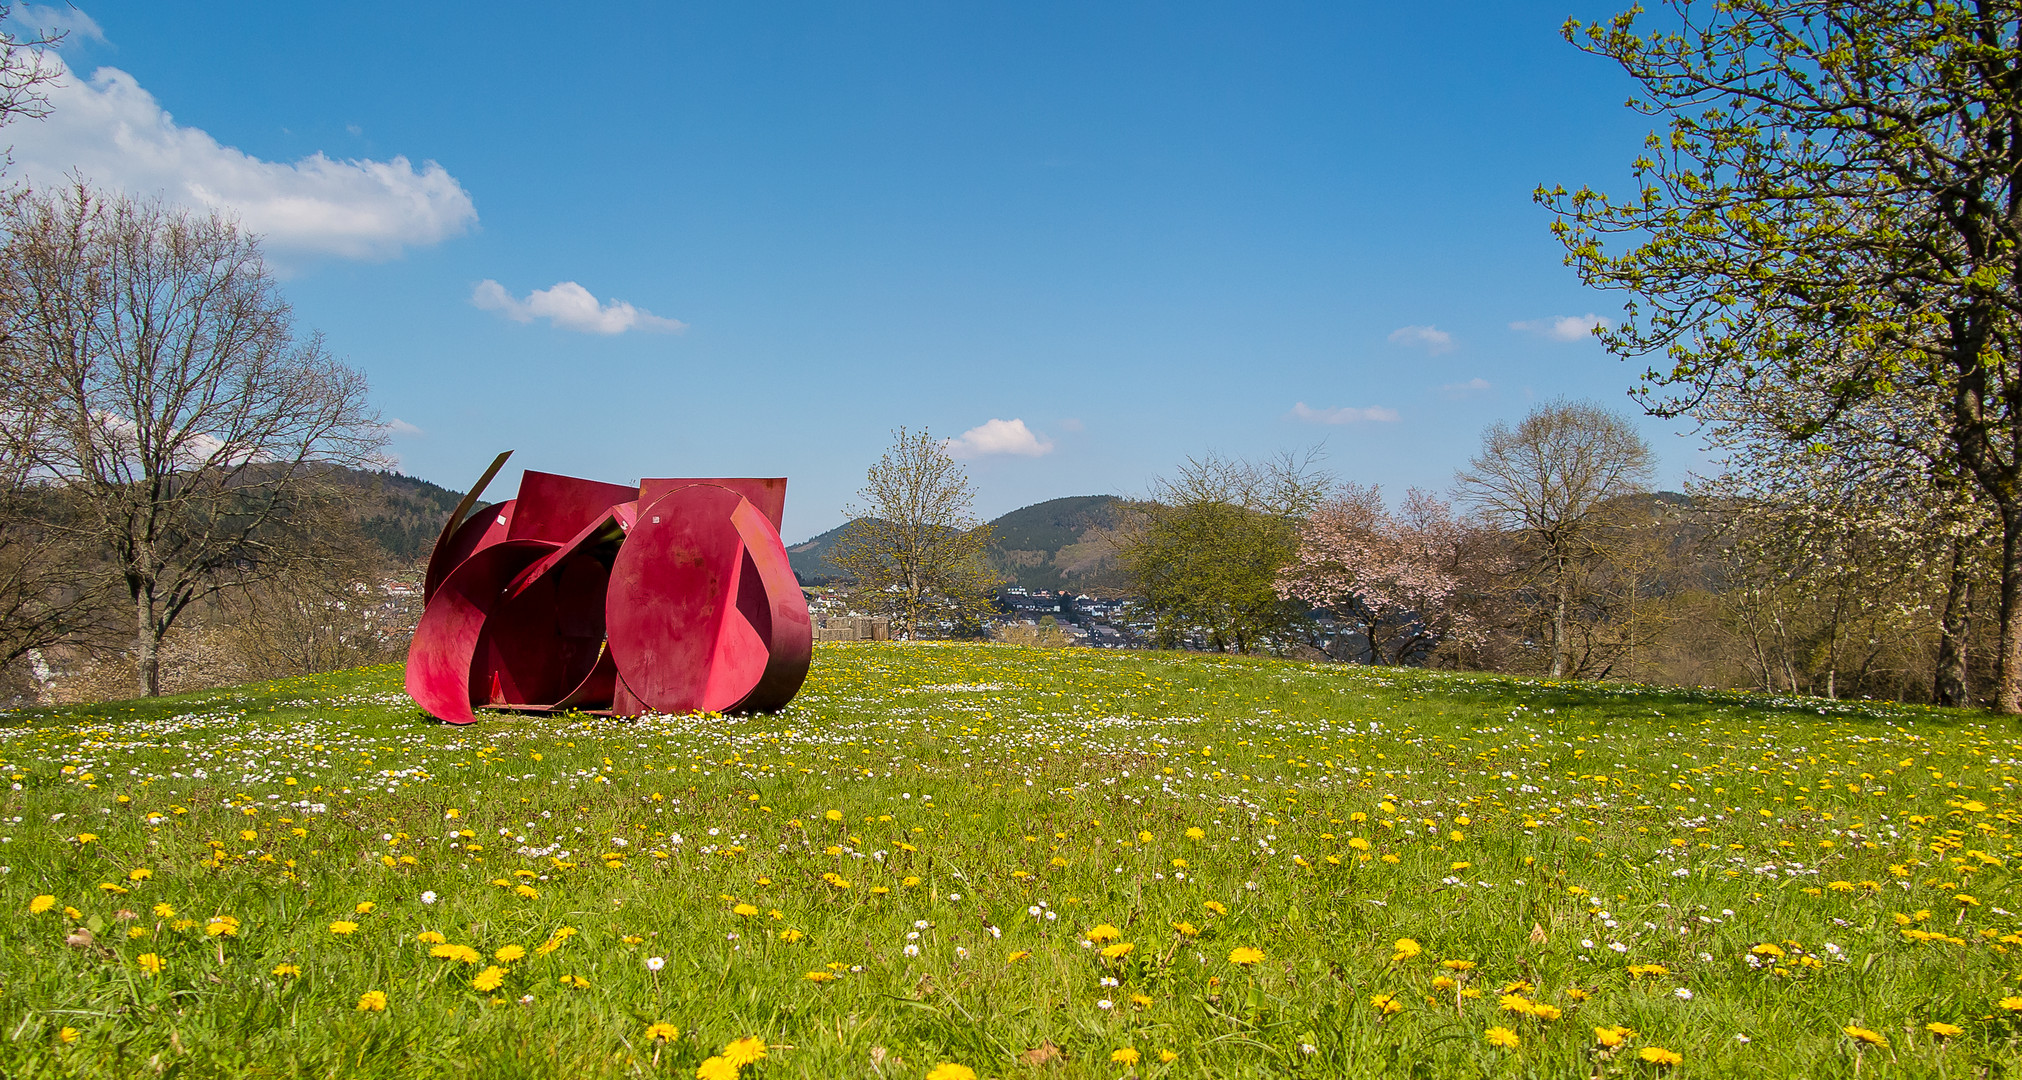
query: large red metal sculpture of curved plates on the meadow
[{"left": 406, "top": 451, "right": 815, "bottom": 724}]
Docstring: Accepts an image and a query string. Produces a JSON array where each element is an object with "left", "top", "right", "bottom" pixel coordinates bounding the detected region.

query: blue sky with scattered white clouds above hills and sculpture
[{"left": 0, "top": 0, "right": 1701, "bottom": 542}]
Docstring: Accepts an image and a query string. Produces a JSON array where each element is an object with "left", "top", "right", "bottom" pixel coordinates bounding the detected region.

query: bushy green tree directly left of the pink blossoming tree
[{"left": 1120, "top": 457, "right": 1326, "bottom": 653}]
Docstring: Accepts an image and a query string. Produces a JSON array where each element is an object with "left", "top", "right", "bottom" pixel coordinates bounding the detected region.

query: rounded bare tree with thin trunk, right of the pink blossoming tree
[{"left": 1454, "top": 400, "right": 1654, "bottom": 678}]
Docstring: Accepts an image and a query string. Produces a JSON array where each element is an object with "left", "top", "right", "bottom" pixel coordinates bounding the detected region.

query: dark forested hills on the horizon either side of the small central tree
[{"left": 787, "top": 496, "right": 1124, "bottom": 595}]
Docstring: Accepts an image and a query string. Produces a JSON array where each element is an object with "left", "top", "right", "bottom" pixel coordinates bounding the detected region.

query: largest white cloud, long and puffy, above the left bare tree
[{"left": 0, "top": 51, "right": 477, "bottom": 259}]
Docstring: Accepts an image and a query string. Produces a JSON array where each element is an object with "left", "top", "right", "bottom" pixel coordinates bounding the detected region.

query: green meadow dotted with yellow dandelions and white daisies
[{"left": 0, "top": 645, "right": 2022, "bottom": 1080}]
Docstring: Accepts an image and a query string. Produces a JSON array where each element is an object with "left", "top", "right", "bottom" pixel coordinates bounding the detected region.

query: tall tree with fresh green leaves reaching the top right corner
[{"left": 1539, "top": 0, "right": 2022, "bottom": 712}]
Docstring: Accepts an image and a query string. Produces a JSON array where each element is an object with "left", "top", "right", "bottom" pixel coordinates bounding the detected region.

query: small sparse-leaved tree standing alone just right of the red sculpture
[{"left": 829, "top": 427, "right": 997, "bottom": 637}]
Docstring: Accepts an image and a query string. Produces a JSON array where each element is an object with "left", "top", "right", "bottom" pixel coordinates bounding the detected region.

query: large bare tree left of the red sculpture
[{"left": 0, "top": 184, "right": 384, "bottom": 696}]
